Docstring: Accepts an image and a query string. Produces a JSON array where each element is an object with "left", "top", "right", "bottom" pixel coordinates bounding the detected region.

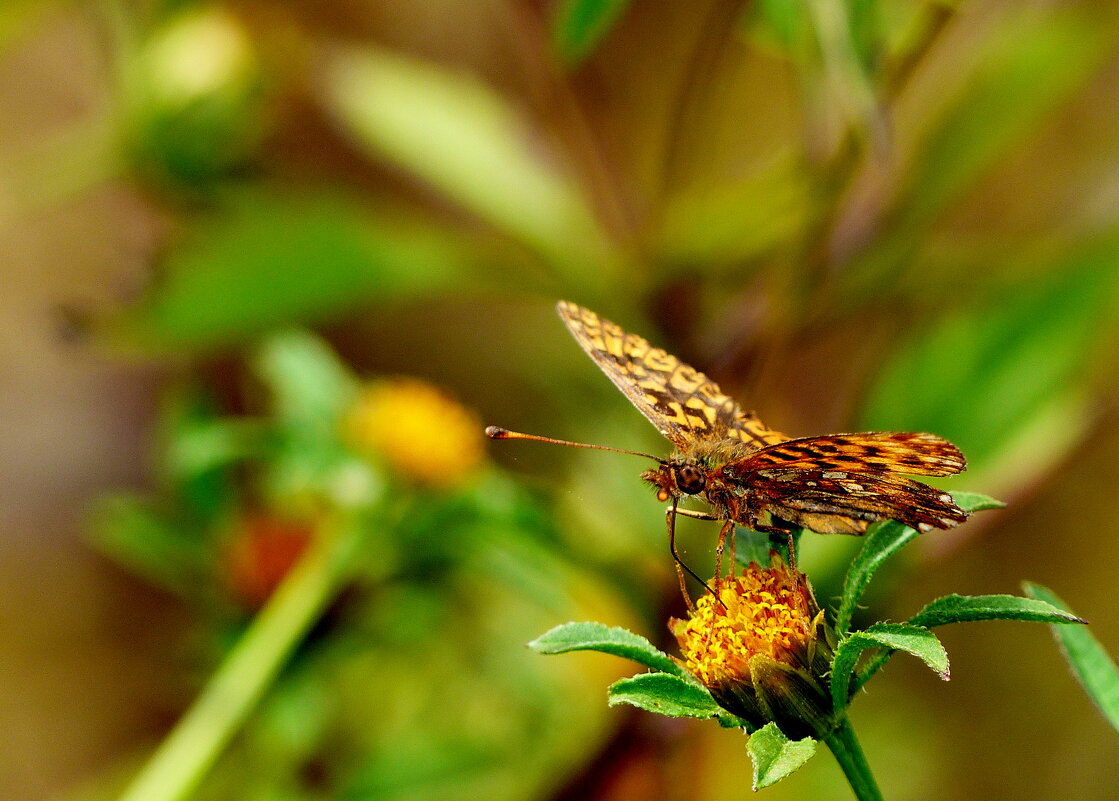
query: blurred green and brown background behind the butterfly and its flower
[{"left": 0, "top": 0, "right": 1119, "bottom": 801}]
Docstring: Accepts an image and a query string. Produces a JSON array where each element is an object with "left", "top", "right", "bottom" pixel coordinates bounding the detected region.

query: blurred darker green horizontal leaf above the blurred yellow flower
[{"left": 110, "top": 196, "right": 461, "bottom": 349}]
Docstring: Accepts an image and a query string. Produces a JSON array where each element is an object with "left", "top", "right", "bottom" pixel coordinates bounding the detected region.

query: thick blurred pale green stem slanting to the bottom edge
[{"left": 120, "top": 521, "right": 360, "bottom": 801}]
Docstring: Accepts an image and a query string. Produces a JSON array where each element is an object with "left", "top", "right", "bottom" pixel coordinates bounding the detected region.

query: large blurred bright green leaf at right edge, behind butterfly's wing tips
[{"left": 859, "top": 246, "right": 1119, "bottom": 486}]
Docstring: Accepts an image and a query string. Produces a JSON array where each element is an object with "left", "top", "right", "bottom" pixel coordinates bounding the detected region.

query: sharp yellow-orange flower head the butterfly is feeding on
[{"left": 668, "top": 554, "right": 834, "bottom": 737}]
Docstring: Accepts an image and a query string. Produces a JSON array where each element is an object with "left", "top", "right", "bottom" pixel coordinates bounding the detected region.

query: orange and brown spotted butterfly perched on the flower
[{"left": 486, "top": 301, "right": 967, "bottom": 595}]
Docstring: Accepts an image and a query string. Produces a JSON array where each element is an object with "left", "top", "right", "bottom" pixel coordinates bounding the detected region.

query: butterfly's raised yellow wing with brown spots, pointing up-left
[{"left": 556, "top": 301, "right": 789, "bottom": 449}]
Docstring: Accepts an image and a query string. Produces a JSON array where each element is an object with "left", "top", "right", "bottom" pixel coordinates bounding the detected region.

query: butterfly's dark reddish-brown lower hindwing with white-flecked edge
[{"left": 751, "top": 468, "right": 968, "bottom": 534}]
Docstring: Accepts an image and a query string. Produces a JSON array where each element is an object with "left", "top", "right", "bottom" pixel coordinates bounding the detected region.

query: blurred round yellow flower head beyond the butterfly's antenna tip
[{"left": 345, "top": 378, "right": 485, "bottom": 488}]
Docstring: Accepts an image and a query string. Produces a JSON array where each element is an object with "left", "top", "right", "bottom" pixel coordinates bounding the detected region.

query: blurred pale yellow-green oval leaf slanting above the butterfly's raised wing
[{"left": 327, "top": 48, "right": 611, "bottom": 289}]
